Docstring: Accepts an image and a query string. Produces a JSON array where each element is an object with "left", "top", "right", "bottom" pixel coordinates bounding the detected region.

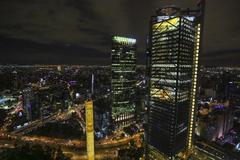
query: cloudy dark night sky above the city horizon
[{"left": 0, "top": 0, "right": 240, "bottom": 66}]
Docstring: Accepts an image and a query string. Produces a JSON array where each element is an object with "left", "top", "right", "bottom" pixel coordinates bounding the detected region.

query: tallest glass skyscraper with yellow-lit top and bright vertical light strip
[{"left": 146, "top": 1, "right": 205, "bottom": 159}]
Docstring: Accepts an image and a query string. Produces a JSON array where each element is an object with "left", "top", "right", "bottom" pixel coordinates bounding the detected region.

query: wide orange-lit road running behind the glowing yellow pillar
[{"left": 0, "top": 132, "right": 143, "bottom": 160}]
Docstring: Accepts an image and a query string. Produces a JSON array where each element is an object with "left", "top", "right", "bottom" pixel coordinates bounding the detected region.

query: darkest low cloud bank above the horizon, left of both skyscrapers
[{"left": 0, "top": 37, "right": 109, "bottom": 65}]
